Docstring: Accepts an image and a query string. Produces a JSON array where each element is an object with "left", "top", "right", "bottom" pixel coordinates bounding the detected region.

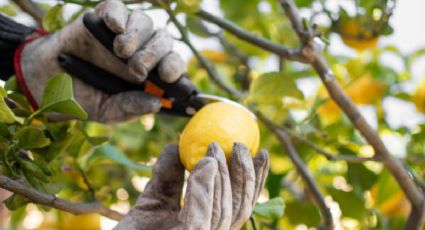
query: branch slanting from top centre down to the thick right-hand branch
[{"left": 197, "top": 10, "right": 306, "bottom": 62}]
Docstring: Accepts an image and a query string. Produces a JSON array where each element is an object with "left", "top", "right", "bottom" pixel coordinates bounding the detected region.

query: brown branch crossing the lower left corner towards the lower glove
[{"left": 0, "top": 175, "right": 123, "bottom": 220}]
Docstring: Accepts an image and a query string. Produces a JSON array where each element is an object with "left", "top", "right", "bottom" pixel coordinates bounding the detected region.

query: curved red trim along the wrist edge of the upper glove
[{"left": 13, "top": 28, "right": 49, "bottom": 111}]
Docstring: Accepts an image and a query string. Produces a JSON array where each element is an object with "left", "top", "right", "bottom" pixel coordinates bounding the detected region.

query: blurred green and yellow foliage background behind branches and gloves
[{"left": 0, "top": 0, "right": 425, "bottom": 229}]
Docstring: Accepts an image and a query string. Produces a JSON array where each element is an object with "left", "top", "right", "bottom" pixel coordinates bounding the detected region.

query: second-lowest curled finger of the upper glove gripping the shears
[{"left": 128, "top": 30, "right": 173, "bottom": 82}]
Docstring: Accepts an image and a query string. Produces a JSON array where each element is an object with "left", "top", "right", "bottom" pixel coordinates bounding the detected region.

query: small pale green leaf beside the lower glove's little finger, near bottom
[{"left": 254, "top": 197, "right": 285, "bottom": 220}]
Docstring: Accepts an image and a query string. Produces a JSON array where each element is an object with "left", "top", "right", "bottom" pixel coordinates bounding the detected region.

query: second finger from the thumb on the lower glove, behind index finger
[{"left": 207, "top": 142, "right": 232, "bottom": 230}]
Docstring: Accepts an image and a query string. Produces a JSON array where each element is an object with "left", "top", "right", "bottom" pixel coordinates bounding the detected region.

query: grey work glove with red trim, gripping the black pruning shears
[{"left": 20, "top": 0, "right": 186, "bottom": 122}]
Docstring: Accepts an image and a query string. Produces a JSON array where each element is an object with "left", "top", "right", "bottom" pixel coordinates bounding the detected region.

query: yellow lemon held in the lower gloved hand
[{"left": 179, "top": 102, "right": 260, "bottom": 171}]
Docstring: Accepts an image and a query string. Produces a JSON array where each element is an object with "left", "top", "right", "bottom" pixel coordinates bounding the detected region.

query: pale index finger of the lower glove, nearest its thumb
[{"left": 179, "top": 157, "right": 218, "bottom": 230}]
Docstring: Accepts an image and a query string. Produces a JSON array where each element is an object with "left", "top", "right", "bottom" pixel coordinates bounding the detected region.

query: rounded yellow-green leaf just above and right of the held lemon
[{"left": 246, "top": 72, "right": 304, "bottom": 104}]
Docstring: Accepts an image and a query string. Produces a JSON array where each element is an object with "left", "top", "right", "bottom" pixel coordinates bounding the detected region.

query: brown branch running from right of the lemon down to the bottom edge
[{"left": 257, "top": 113, "right": 334, "bottom": 229}]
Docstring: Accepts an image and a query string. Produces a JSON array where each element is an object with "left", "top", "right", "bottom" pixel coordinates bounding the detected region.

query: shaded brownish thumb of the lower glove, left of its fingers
[{"left": 114, "top": 144, "right": 184, "bottom": 230}]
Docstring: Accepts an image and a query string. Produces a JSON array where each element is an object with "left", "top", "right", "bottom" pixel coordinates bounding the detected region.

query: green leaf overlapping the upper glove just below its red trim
[{"left": 36, "top": 74, "right": 87, "bottom": 120}]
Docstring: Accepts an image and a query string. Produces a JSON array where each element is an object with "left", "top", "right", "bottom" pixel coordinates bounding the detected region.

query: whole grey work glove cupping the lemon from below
[{"left": 114, "top": 143, "right": 269, "bottom": 230}]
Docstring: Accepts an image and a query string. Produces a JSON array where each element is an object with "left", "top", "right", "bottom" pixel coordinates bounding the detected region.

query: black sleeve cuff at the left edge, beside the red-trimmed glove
[{"left": 0, "top": 14, "right": 34, "bottom": 80}]
